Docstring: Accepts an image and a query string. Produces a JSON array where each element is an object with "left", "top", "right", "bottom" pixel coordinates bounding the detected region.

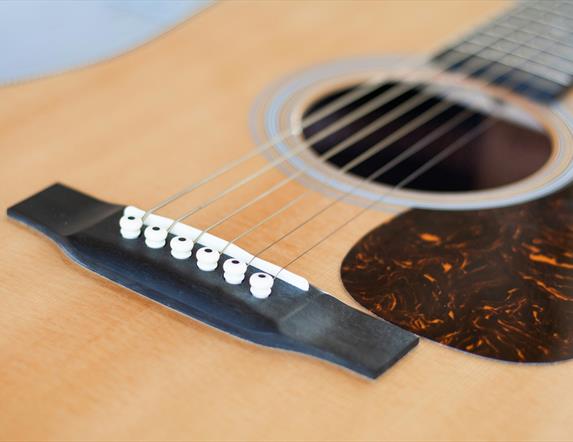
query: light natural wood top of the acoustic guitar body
[{"left": 0, "top": 1, "right": 573, "bottom": 440}]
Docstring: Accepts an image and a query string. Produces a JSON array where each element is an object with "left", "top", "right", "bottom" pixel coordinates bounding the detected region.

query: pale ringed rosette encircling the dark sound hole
[{"left": 252, "top": 55, "right": 573, "bottom": 211}]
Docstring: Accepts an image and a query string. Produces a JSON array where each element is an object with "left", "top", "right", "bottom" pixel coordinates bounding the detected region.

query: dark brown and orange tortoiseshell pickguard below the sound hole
[{"left": 341, "top": 187, "right": 573, "bottom": 362}]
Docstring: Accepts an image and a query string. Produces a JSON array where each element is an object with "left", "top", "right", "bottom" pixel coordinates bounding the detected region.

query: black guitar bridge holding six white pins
[{"left": 8, "top": 184, "right": 418, "bottom": 378}]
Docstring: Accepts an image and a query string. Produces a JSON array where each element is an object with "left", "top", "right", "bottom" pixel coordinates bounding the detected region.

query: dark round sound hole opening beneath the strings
[{"left": 303, "top": 83, "right": 551, "bottom": 192}]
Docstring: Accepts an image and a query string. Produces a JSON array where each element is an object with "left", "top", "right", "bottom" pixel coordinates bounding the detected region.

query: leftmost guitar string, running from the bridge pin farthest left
[{"left": 142, "top": 3, "right": 519, "bottom": 221}]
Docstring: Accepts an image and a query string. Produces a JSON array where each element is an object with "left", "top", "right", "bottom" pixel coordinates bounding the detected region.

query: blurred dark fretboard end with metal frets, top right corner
[{"left": 432, "top": 1, "right": 573, "bottom": 102}]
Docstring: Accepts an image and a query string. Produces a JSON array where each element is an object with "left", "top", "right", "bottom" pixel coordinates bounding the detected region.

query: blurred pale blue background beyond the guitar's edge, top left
[{"left": 0, "top": 0, "right": 213, "bottom": 85}]
